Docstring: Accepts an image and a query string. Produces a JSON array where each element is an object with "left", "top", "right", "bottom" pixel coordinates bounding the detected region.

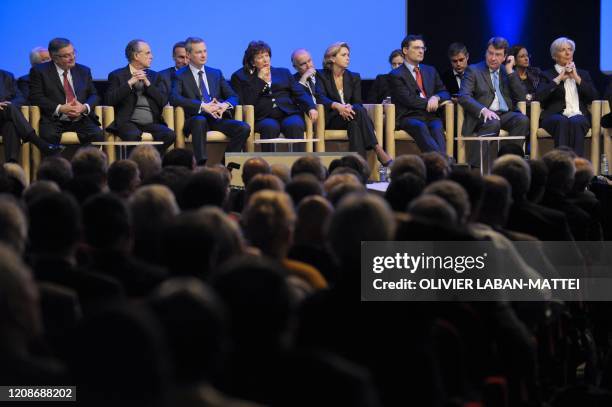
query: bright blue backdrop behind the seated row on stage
[{"left": 0, "top": 0, "right": 406, "bottom": 79}]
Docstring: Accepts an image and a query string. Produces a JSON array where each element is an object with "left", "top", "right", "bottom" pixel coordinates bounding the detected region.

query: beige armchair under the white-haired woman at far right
[{"left": 529, "top": 100, "right": 603, "bottom": 174}]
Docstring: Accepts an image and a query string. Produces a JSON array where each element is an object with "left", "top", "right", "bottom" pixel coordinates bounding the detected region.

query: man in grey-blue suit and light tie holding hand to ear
[{"left": 459, "top": 37, "right": 529, "bottom": 166}]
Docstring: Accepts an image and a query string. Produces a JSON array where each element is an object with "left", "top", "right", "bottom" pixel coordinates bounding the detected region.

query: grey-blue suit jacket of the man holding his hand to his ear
[{"left": 459, "top": 61, "right": 526, "bottom": 135}]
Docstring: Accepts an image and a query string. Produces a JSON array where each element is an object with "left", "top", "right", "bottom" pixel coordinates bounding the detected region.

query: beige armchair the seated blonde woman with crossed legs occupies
[{"left": 314, "top": 104, "right": 383, "bottom": 179}]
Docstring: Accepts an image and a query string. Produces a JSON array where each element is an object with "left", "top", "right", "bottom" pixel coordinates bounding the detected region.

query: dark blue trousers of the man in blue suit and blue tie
[{"left": 185, "top": 115, "right": 251, "bottom": 164}]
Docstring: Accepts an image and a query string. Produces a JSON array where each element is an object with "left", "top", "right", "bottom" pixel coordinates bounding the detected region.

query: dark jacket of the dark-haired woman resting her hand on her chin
[{"left": 232, "top": 68, "right": 316, "bottom": 120}]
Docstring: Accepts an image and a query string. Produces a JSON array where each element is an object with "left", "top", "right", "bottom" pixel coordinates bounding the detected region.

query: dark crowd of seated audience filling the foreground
[{"left": 0, "top": 146, "right": 612, "bottom": 407}]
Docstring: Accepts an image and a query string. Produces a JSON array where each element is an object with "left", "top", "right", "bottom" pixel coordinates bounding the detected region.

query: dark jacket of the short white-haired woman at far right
[{"left": 535, "top": 68, "right": 598, "bottom": 121}]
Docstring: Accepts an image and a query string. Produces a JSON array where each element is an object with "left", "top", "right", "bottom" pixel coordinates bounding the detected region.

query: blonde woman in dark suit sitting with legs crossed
[{"left": 316, "top": 42, "right": 391, "bottom": 166}]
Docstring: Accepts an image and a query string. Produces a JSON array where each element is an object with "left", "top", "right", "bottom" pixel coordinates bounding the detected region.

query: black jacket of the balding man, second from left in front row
[{"left": 106, "top": 65, "right": 167, "bottom": 132}]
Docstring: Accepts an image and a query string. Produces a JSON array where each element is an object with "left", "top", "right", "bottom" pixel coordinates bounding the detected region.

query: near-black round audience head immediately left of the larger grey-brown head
[{"left": 83, "top": 193, "right": 132, "bottom": 252}]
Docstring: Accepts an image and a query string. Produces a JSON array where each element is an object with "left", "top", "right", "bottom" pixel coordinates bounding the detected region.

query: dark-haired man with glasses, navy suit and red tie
[{"left": 389, "top": 35, "right": 450, "bottom": 154}]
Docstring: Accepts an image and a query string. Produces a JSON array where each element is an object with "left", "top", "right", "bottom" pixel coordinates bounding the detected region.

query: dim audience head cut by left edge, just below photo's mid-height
[{"left": 0, "top": 194, "right": 28, "bottom": 255}]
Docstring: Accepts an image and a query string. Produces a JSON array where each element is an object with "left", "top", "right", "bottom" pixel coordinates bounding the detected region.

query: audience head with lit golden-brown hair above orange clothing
[{"left": 242, "top": 190, "right": 295, "bottom": 260}]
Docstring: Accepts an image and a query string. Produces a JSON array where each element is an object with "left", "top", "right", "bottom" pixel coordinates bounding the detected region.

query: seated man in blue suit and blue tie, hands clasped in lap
[{"left": 170, "top": 37, "right": 251, "bottom": 165}]
